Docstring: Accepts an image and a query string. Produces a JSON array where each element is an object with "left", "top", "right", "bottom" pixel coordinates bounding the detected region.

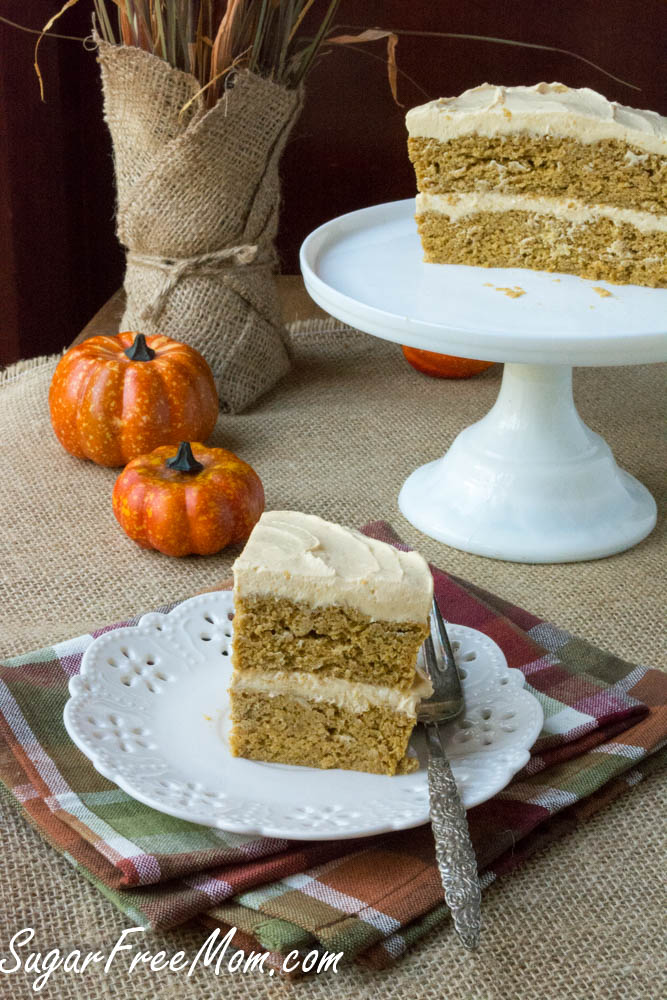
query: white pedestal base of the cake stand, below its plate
[{"left": 398, "top": 364, "right": 656, "bottom": 563}]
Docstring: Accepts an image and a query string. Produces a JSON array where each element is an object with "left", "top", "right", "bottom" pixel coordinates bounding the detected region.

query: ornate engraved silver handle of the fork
[{"left": 426, "top": 725, "right": 481, "bottom": 948}]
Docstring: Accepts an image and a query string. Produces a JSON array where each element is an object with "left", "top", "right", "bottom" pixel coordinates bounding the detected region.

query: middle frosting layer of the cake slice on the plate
[{"left": 230, "top": 670, "right": 433, "bottom": 716}]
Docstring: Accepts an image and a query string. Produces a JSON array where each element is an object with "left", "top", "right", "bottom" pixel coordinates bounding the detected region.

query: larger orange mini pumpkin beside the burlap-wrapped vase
[{"left": 49, "top": 333, "right": 218, "bottom": 466}]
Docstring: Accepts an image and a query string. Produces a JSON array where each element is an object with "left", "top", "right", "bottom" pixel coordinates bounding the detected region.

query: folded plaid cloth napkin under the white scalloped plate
[{"left": 0, "top": 522, "right": 667, "bottom": 968}]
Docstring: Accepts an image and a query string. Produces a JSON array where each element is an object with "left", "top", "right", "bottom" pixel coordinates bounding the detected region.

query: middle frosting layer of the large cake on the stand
[{"left": 416, "top": 191, "right": 667, "bottom": 233}]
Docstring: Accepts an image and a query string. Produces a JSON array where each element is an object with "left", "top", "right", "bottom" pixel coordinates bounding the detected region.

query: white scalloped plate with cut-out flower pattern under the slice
[{"left": 64, "top": 591, "right": 543, "bottom": 840}]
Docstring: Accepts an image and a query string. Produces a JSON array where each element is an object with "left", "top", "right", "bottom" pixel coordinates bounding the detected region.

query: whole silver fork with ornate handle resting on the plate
[{"left": 417, "top": 599, "right": 481, "bottom": 948}]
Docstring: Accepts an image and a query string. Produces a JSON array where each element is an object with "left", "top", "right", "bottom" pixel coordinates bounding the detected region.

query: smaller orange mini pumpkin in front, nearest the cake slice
[{"left": 113, "top": 441, "right": 264, "bottom": 556}]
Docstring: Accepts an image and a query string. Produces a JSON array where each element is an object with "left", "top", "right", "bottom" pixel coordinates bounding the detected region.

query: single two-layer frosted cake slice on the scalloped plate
[{"left": 230, "top": 511, "right": 433, "bottom": 774}]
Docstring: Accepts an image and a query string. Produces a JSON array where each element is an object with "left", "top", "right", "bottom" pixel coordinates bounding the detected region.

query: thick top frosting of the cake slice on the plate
[{"left": 232, "top": 510, "right": 433, "bottom": 622}]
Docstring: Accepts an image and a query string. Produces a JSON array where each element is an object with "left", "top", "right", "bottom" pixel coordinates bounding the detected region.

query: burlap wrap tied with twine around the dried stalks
[{"left": 97, "top": 39, "right": 301, "bottom": 412}]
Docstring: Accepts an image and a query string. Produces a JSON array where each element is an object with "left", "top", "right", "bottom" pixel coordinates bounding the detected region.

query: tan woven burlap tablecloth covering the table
[{"left": 0, "top": 324, "right": 667, "bottom": 1000}]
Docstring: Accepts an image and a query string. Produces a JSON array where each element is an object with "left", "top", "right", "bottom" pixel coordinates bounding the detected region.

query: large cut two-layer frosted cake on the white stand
[{"left": 406, "top": 83, "right": 667, "bottom": 288}]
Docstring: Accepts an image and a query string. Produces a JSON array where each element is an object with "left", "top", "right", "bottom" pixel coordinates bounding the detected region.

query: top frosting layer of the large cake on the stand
[{"left": 406, "top": 83, "right": 667, "bottom": 155}]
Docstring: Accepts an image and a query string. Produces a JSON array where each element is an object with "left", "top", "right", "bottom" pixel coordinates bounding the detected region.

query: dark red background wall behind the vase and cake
[{"left": 0, "top": 0, "right": 667, "bottom": 364}]
